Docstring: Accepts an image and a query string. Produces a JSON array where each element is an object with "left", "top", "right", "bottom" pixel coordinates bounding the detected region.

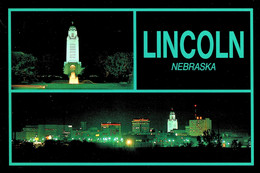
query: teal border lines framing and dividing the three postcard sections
[{"left": 8, "top": 8, "right": 254, "bottom": 166}]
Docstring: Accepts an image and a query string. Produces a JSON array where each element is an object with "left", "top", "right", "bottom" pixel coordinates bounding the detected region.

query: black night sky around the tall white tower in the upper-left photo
[{"left": 12, "top": 12, "right": 133, "bottom": 66}]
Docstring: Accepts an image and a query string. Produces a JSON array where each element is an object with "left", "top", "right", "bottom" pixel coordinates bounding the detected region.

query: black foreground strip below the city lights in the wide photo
[{"left": 13, "top": 142, "right": 251, "bottom": 162}]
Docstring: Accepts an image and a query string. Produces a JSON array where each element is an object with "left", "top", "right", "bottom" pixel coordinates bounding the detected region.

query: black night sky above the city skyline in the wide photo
[{"left": 12, "top": 93, "right": 250, "bottom": 132}]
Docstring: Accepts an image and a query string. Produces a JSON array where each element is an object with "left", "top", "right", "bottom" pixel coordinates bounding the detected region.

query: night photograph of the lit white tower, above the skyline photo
[{"left": 11, "top": 11, "right": 133, "bottom": 89}]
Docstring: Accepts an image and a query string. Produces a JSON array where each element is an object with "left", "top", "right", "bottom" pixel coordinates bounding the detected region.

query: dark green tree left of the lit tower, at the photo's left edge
[{"left": 12, "top": 52, "right": 37, "bottom": 83}]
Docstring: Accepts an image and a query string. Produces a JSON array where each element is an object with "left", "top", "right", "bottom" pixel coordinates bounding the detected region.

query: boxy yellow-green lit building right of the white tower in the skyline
[{"left": 187, "top": 116, "right": 212, "bottom": 136}]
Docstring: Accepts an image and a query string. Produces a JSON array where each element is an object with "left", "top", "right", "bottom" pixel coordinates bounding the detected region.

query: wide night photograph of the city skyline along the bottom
[{"left": 12, "top": 93, "right": 251, "bottom": 162}]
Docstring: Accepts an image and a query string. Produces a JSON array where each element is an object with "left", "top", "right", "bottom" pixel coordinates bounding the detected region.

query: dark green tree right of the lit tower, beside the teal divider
[{"left": 103, "top": 52, "right": 133, "bottom": 81}]
